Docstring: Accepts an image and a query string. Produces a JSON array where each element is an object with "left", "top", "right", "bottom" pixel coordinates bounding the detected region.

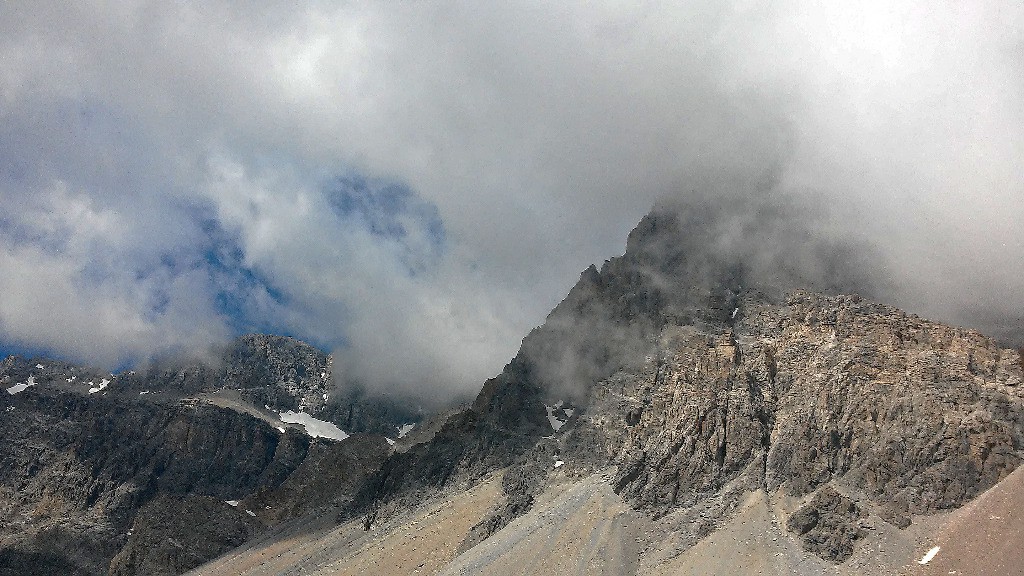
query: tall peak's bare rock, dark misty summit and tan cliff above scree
[{"left": 350, "top": 203, "right": 1024, "bottom": 562}]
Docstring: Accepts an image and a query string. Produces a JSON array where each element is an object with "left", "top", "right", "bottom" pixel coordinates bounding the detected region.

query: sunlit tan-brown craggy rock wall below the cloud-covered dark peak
[{"left": 593, "top": 292, "right": 1024, "bottom": 560}]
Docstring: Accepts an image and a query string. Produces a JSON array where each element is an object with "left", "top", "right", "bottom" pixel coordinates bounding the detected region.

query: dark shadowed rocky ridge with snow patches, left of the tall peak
[{"left": 0, "top": 335, "right": 412, "bottom": 575}]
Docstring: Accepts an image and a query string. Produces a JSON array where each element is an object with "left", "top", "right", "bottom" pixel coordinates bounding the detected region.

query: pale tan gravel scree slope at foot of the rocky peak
[{"left": 188, "top": 461, "right": 1024, "bottom": 576}]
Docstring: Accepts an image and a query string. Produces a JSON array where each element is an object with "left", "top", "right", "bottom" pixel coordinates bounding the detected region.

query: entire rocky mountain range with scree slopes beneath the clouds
[{"left": 0, "top": 203, "right": 1024, "bottom": 576}]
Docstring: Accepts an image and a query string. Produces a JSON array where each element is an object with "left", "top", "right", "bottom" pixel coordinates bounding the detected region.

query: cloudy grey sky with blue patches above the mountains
[{"left": 0, "top": 0, "right": 1024, "bottom": 392}]
